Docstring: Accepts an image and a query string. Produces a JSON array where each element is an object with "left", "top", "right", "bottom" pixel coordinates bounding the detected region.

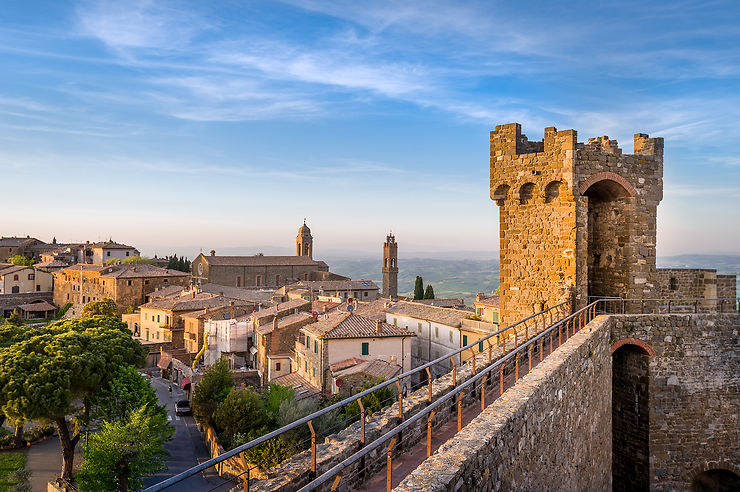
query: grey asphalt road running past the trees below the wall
[{"left": 144, "top": 377, "right": 230, "bottom": 492}]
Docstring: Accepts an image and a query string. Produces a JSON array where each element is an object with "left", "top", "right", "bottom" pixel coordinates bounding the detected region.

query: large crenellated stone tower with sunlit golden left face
[{"left": 490, "top": 123, "right": 663, "bottom": 324}]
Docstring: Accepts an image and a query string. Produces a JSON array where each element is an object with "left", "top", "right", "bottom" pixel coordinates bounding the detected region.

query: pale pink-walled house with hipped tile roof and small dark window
[{"left": 293, "top": 311, "right": 415, "bottom": 393}]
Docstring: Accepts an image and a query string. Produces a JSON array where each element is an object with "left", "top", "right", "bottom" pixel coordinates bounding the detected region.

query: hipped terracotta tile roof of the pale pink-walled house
[{"left": 306, "top": 312, "right": 416, "bottom": 340}]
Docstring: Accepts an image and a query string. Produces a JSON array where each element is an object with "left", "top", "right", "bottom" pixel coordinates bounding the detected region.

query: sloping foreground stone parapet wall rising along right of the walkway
[{"left": 394, "top": 317, "right": 612, "bottom": 492}]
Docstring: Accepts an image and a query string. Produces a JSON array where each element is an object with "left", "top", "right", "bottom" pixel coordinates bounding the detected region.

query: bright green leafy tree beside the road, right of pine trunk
[{"left": 76, "top": 405, "right": 175, "bottom": 492}]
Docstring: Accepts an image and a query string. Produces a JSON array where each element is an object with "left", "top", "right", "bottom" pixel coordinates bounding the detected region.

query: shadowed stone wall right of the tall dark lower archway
[{"left": 611, "top": 314, "right": 740, "bottom": 491}]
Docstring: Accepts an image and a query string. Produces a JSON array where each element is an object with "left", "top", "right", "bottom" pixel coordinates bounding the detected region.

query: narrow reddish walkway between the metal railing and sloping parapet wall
[{"left": 357, "top": 320, "right": 566, "bottom": 492}]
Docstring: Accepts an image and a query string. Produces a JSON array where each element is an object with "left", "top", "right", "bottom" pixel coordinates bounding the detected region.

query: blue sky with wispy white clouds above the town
[{"left": 0, "top": 0, "right": 740, "bottom": 257}]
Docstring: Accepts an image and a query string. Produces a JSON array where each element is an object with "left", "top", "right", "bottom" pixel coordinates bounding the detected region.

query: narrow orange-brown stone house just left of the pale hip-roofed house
[{"left": 254, "top": 311, "right": 316, "bottom": 385}]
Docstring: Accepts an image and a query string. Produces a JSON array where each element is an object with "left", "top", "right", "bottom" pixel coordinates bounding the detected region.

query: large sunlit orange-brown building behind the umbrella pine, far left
[{"left": 53, "top": 263, "right": 190, "bottom": 315}]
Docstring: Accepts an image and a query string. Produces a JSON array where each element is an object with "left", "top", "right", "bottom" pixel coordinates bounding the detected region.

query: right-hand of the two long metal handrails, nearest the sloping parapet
[{"left": 298, "top": 301, "right": 599, "bottom": 492}]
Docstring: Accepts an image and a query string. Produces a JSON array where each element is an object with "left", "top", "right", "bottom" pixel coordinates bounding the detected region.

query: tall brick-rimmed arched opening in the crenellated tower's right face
[{"left": 583, "top": 179, "right": 635, "bottom": 297}]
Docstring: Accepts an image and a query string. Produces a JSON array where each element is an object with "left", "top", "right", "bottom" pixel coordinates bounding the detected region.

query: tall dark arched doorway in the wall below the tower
[{"left": 612, "top": 341, "right": 652, "bottom": 492}]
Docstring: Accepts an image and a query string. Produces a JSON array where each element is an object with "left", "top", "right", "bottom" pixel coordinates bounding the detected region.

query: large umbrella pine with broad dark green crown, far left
[{"left": 0, "top": 316, "right": 146, "bottom": 479}]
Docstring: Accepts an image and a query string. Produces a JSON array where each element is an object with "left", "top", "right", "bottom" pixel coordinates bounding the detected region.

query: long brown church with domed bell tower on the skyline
[{"left": 191, "top": 220, "right": 345, "bottom": 288}]
